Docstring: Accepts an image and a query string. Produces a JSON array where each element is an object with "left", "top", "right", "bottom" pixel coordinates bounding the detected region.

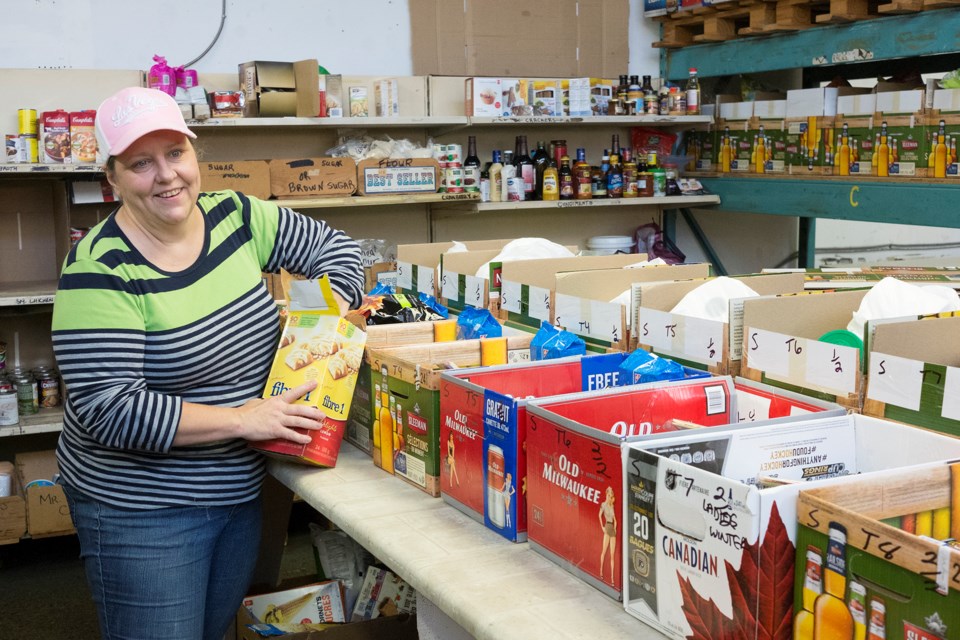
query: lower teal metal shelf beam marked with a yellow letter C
[{"left": 698, "top": 176, "right": 960, "bottom": 229}]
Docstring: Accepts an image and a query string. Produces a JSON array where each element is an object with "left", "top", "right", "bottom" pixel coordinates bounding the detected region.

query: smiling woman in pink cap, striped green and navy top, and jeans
[{"left": 53, "top": 88, "right": 363, "bottom": 640}]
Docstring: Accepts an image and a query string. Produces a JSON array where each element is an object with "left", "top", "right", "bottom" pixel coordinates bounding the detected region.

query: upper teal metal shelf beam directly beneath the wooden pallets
[{"left": 665, "top": 9, "right": 960, "bottom": 81}]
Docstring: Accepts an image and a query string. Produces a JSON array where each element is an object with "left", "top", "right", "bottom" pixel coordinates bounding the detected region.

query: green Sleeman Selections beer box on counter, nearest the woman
[{"left": 365, "top": 335, "right": 533, "bottom": 496}]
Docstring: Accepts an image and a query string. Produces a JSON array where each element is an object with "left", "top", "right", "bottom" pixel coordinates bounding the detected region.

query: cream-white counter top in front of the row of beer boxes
[{"left": 269, "top": 443, "right": 664, "bottom": 640}]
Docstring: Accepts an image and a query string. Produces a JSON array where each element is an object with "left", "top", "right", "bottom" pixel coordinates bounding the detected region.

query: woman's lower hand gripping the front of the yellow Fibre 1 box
[{"left": 237, "top": 381, "right": 323, "bottom": 444}]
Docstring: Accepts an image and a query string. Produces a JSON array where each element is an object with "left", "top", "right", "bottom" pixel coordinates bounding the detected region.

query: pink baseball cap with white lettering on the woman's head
[{"left": 96, "top": 87, "right": 197, "bottom": 157}]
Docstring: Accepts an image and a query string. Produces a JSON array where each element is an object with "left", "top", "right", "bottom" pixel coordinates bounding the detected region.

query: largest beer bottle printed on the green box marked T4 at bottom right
[{"left": 813, "top": 522, "right": 853, "bottom": 640}]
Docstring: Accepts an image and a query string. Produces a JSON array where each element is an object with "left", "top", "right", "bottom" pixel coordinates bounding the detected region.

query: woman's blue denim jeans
[{"left": 64, "top": 487, "right": 261, "bottom": 640}]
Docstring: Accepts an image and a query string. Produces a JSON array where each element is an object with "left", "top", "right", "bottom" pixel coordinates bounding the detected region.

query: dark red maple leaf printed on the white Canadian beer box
[{"left": 677, "top": 502, "right": 795, "bottom": 640}]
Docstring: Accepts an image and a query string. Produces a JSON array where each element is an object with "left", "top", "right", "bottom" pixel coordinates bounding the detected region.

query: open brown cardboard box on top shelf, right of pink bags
[{"left": 238, "top": 59, "right": 320, "bottom": 118}]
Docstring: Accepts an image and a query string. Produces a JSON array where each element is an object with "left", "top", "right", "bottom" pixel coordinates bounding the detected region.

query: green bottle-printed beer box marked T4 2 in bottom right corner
[{"left": 794, "top": 463, "right": 960, "bottom": 640}]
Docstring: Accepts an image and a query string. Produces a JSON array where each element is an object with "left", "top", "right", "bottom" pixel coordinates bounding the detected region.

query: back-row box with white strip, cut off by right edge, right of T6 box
[{"left": 863, "top": 316, "right": 960, "bottom": 436}]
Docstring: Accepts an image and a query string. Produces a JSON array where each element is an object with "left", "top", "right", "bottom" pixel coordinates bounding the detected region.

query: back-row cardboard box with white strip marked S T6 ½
[{"left": 740, "top": 290, "right": 866, "bottom": 411}]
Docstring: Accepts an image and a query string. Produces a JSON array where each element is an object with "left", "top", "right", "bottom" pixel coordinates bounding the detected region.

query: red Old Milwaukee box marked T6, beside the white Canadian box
[{"left": 526, "top": 376, "right": 836, "bottom": 599}]
